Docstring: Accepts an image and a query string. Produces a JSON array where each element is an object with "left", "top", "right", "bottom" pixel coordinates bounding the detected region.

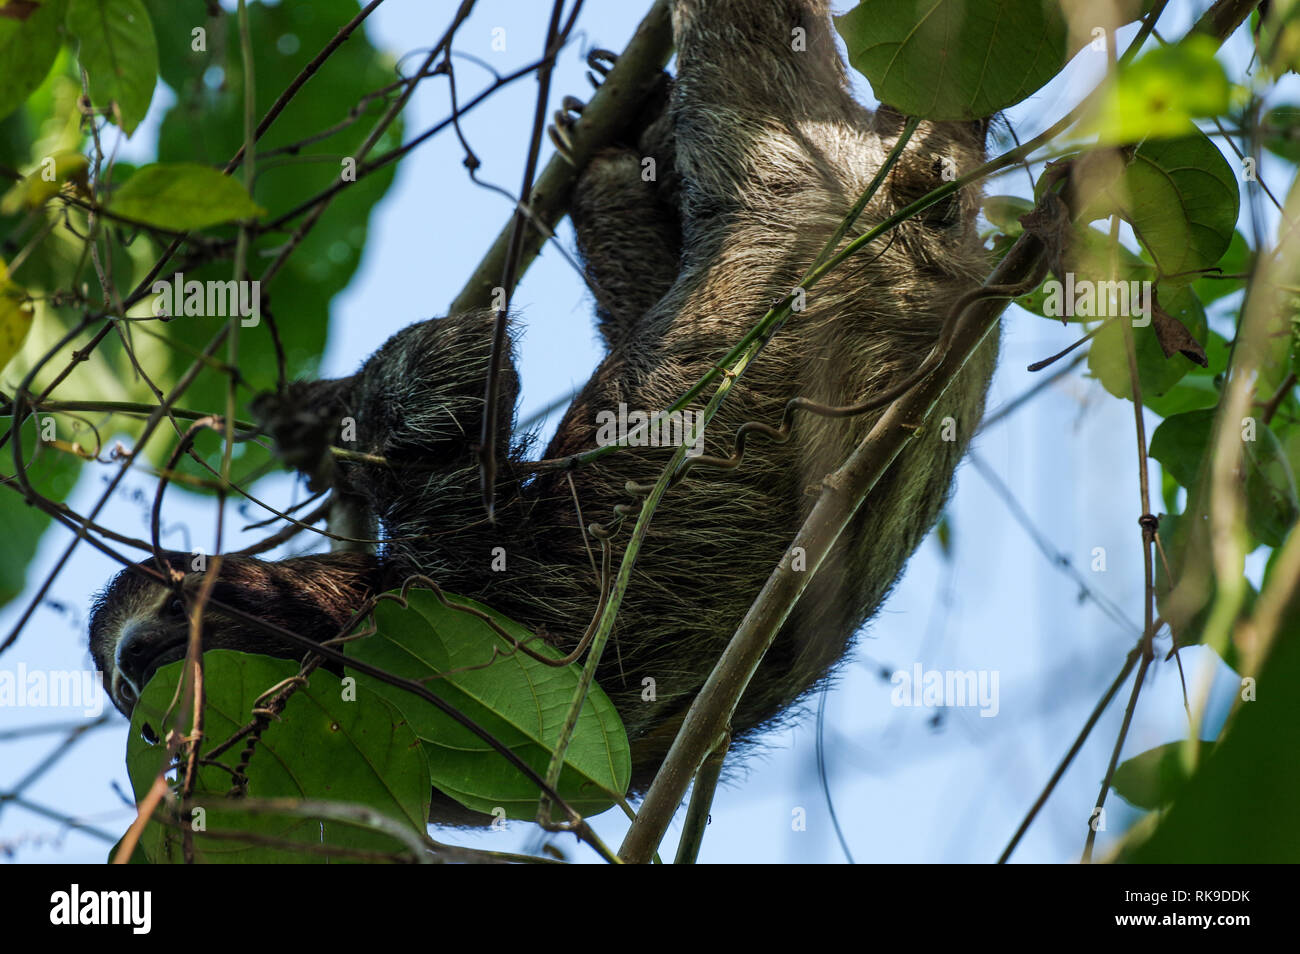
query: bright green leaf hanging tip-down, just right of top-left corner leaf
[{"left": 68, "top": 0, "right": 159, "bottom": 135}]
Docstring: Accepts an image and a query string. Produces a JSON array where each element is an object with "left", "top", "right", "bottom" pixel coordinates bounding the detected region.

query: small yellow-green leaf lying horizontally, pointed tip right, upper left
[{"left": 108, "top": 162, "right": 265, "bottom": 231}]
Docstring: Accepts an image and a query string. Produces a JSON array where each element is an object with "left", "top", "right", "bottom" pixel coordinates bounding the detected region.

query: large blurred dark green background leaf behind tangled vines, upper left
[{"left": 142, "top": 0, "right": 402, "bottom": 408}]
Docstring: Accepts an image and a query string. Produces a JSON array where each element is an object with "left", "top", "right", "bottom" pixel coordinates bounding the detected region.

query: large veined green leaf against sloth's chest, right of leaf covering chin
[{"left": 347, "top": 590, "right": 632, "bottom": 819}]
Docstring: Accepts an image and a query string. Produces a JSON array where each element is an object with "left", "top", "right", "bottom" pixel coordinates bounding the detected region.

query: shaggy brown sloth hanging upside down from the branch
[{"left": 91, "top": 0, "right": 996, "bottom": 821}]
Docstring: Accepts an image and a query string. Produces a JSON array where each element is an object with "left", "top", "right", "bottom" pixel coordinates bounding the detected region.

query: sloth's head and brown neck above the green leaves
[{"left": 90, "top": 552, "right": 381, "bottom": 716}]
